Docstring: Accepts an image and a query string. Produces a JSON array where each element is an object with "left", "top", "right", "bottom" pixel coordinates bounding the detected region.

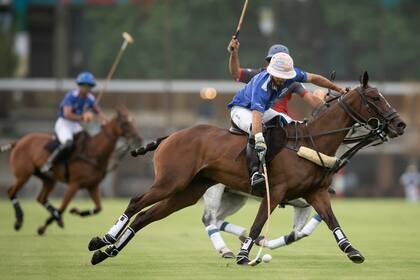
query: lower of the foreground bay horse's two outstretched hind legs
[{"left": 91, "top": 179, "right": 214, "bottom": 265}]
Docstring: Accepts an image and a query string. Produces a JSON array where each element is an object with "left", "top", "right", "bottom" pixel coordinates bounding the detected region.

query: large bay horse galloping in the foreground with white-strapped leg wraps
[{"left": 88, "top": 72, "right": 406, "bottom": 265}]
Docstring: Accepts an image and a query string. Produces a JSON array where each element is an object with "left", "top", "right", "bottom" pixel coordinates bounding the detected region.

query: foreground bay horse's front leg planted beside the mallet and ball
[{"left": 236, "top": 185, "right": 284, "bottom": 265}]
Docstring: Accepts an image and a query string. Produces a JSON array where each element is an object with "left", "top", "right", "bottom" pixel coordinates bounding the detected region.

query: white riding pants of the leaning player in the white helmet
[{"left": 230, "top": 106, "right": 293, "bottom": 134}]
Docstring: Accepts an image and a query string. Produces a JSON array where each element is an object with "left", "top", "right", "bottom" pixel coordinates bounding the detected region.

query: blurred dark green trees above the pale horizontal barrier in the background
[{"left": 0, "top": 0, "right": 420, "bottom": 81}]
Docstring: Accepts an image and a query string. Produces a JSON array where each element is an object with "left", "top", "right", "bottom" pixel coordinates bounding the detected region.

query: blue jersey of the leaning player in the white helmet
[{"left": 228, "top": 68, "right": 307, "bottom": 113}]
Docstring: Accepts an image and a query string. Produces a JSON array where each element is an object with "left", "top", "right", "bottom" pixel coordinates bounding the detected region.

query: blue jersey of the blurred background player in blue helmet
[{"left": 59, "top": 89, "right": 96, "bottom": 118}]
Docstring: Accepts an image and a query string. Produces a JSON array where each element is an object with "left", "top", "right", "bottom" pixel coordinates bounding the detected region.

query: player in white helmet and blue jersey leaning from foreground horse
[{"left": 228, "top": 53, "right": 345, "bottom": 192}]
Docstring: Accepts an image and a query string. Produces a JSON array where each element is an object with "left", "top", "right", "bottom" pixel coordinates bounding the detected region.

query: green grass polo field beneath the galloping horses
[{"left": 0, "top": 200, "right": 420, "bottom": 280}]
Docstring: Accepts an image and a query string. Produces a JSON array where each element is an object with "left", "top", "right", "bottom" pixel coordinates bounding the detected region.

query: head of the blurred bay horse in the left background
[{"left": 110, "top": 106, "right": 142, "bottom": 143}]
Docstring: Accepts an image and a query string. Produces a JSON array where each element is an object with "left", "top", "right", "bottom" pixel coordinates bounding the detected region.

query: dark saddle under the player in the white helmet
[{"left": 229, "top": 116, "right": 287, "bottom": 163}]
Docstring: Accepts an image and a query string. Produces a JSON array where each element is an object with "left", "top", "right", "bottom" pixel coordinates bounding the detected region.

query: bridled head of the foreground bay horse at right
[{"left": 353, "top": 72, "right": 407, "bottom": 138}]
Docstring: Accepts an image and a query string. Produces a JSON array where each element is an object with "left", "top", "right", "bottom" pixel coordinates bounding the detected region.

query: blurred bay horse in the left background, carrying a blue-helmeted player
[{"left": 1, "top": 107, "right": 141, "bottom": 235}]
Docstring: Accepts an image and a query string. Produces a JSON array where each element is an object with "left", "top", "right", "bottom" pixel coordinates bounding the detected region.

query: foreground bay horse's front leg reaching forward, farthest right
[{"left": 307, "top": 189, "right": 365, "bottom": 263}]
